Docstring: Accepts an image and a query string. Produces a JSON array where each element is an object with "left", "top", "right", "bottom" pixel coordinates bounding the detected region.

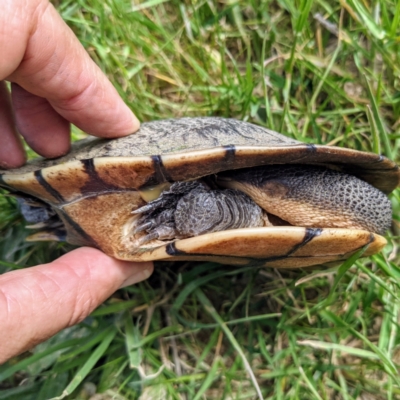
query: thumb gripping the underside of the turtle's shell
[{"left": 0, "top": 248, "right": 153, "bottom": 363}]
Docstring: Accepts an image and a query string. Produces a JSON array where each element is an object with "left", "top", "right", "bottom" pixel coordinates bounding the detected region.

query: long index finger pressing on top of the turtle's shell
[{"left": 0, "top": 0, "right": 139, "bottom": 137}]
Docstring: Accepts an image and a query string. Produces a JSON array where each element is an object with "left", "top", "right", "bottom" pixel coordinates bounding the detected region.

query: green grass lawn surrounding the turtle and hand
[{"left": 0, "top": 0, "right": 400, "bottom": 400}]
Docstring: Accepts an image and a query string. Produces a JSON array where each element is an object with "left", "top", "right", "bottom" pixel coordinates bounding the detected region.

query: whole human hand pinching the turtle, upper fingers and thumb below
[{"left": 0, "top": 0, "right": 153, "bottom": 363}]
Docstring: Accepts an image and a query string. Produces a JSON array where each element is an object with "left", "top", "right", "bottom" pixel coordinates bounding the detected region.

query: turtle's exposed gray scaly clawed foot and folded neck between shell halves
[{"left": 134, "top": 165, "right": 392, "bottom": 243}]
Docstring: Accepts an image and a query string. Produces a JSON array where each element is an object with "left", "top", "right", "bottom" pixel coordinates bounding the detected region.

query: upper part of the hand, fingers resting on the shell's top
[{"left": 0, "top": 0, "right": 139, "bottom": 168}]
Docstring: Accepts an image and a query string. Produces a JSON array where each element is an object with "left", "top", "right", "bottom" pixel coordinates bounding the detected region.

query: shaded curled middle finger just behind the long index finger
[{"left": 11, "top": 83, "right": 70, "bottom": 158}]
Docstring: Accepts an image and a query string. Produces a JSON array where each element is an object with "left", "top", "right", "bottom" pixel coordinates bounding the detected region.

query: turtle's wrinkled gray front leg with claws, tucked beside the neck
[{"left": 134, "top": 181, "right": 266, "bottom": 244}]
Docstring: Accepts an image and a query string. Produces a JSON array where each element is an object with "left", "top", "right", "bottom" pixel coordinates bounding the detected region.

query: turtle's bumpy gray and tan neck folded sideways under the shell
[{"left": 217, "top": 165, "right": 392, "bottom": 234}]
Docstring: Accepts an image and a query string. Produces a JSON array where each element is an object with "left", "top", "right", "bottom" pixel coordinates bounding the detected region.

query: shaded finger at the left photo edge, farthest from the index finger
[{"left": 0, "top": 81, "right": 26, "bottom": 168}]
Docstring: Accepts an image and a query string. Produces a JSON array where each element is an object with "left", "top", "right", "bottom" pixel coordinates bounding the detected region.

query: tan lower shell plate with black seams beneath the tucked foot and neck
[{"left": 121, "top": 227, "right": 386, "bottom": 268}]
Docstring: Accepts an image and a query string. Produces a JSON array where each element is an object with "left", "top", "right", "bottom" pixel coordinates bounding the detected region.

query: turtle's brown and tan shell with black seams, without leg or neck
[{"left": 0, "top": 117, "right": 400, "bottom": 268}]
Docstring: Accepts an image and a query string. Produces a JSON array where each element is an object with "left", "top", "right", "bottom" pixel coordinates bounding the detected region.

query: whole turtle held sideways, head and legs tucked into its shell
[{"left": 0, "top": 117, "right": 400, "bottom": 268}]
